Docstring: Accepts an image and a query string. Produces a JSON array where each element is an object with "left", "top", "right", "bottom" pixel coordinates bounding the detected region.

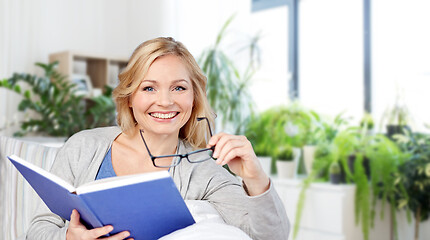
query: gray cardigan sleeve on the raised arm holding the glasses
[{"left": 183, "top": 162, "right": 290, "bottom": 240}]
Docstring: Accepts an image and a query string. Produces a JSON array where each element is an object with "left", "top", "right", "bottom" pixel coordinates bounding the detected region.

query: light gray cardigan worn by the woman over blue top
[{"left": 27, "top": 127, "right": 290, "bottom": 240}]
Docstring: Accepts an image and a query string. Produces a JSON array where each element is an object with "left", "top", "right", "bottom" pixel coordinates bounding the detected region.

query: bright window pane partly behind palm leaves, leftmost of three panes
[{"left": 250, "top": 6, "right": 290, "bottom": 111}]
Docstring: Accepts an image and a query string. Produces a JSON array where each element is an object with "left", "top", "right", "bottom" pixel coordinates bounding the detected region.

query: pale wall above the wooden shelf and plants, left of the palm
[{"left": 0, "top": 0, "right": 172, "bottom": 135}]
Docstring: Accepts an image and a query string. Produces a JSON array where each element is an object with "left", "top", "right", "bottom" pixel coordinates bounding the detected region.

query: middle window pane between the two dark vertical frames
[{"left": 298, "top": 0, "right": 364, "bottom": 119}]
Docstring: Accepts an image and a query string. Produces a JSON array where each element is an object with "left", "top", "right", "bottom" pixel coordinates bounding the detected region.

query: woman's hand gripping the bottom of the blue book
[{"left": 66, "top": 209, "right": 130, "bottom": 240}]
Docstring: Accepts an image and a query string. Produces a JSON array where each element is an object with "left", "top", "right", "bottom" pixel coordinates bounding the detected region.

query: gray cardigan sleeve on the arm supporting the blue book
[{"left": 27, "top": 127, "right": 121, "bottom": 239}]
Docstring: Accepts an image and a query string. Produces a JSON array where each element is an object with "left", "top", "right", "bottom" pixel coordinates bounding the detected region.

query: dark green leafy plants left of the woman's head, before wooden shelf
[{"left": 0, "top": 62, "right": 115, "bottom": 137}]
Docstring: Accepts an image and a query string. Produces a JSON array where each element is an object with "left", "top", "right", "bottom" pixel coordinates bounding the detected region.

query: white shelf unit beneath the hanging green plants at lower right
[{"left": 271, "top": 176, "right": 430, "bottom": 240}]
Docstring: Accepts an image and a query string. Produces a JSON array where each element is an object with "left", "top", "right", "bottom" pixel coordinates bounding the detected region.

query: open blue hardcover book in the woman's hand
[{"left": 8, "top": 155, "right": 195, "bottom": 240}]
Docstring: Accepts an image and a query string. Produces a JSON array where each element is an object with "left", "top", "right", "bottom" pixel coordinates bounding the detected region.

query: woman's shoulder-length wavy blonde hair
[{"left": 113, "top": 37, "right": 215, "bottom": 148}]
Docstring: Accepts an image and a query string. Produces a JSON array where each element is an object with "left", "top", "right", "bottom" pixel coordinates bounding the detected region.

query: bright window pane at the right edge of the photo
[{"left": 372, "top": 0, "right": 430, "bottom": 131}]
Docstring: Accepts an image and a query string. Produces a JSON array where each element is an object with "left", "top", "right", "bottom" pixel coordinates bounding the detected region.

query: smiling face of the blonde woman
[{"left": 129, "top": 55, "right": 194, "bottom": 136}]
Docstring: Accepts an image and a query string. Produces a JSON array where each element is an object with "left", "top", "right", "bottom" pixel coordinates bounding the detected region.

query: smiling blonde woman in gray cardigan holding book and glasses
[{"left": 27, "top": 38, "right": 289, "bottom": 240}]
